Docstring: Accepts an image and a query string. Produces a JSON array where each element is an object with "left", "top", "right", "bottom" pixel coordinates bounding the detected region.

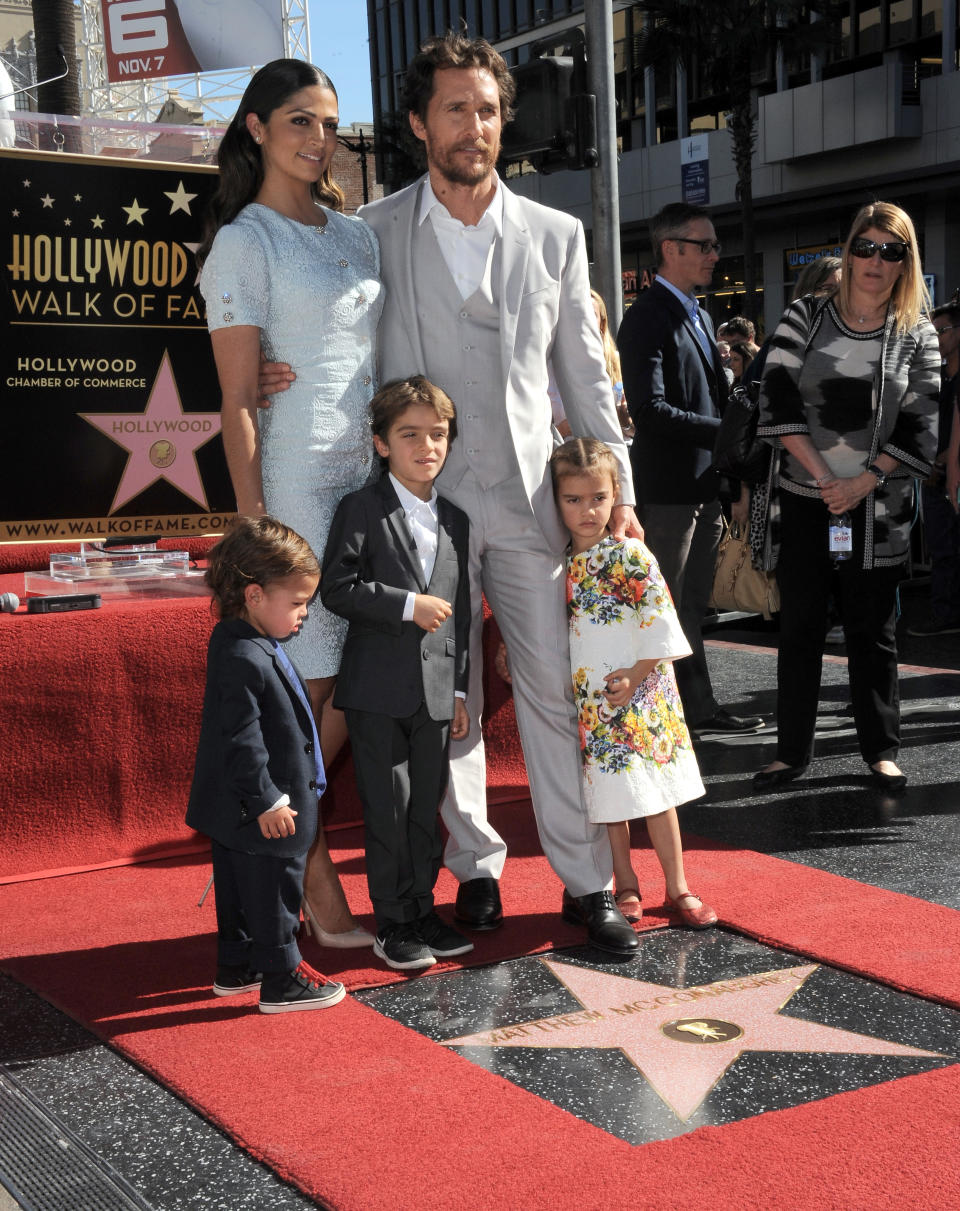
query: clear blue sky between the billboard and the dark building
[{"left": 306, "top": 0, "right": 373, "bottom": 126}]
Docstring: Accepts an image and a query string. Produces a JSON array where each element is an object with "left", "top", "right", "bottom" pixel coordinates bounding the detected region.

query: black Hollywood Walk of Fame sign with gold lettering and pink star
[{"left": 0, "top": 149, "right": 235, "bottom": 541}]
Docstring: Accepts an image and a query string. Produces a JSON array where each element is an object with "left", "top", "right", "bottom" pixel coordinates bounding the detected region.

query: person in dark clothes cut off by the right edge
[{"left": 907, "top": 298, "right": 960, "bottom": 639}]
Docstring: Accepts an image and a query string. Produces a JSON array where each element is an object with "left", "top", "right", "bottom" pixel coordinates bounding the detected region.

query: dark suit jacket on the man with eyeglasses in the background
[{"left": 616, "top": 282, "right": 726, "bottom": 505}]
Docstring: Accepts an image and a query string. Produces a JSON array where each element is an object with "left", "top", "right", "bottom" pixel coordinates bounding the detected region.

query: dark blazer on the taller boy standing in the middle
[{"left": 320, "top": 474, "right": 470, "bottom": 721}]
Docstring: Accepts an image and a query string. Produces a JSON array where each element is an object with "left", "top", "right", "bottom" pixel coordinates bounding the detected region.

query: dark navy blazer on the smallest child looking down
[{"left": 186, "top": 618, "right": 324, "bottom": 857}]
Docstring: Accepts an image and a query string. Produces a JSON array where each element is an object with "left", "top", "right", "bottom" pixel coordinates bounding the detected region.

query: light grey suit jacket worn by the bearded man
[{"left": 361, "top": 180, "right": 633, "bottom": 551}]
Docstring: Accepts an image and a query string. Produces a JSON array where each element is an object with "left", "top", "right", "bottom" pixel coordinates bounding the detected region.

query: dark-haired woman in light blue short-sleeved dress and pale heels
[{"left": 199, "top": 59, "right": 383, "bottom": 946}]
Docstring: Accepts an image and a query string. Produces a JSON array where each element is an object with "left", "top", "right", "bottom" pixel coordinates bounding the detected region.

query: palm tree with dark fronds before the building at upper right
[{"left": 637, "top": 0, "right": 838, "bottom": 315}]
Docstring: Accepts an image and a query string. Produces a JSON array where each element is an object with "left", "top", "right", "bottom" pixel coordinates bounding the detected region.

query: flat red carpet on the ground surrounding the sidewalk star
[{"left": 0, "top": 804, "right": 960, "bottom": 1211}]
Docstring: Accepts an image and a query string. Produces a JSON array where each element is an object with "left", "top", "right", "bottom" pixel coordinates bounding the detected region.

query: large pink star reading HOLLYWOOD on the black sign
[{"left": 80, "top": 350, "right": 220, "bottom": 513}]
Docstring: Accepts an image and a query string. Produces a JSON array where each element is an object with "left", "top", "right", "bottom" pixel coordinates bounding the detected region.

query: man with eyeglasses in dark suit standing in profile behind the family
[{"left": 616, "top": 202, "right": 763, "bottom": 737}]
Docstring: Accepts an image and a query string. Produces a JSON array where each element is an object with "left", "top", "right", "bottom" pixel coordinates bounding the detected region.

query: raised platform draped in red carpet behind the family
[{"left": 0, "top": 573, "right": 527, "bottom": 882}]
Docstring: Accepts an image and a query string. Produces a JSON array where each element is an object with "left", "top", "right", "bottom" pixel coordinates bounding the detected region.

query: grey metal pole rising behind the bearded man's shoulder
[{"left": 584, "top": 0, "right": 623, "bottom": 333}]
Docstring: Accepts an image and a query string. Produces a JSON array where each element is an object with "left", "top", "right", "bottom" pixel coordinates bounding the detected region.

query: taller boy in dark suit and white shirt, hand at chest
[{"left": 321, "top": 375, "right": 473, "bottom": 970}]
